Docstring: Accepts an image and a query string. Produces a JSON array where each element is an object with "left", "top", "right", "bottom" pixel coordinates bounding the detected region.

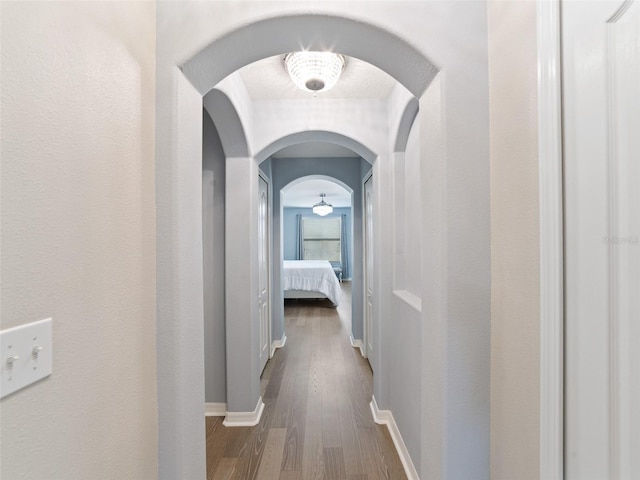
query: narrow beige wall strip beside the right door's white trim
[{"left": 488, "top": 1, "right": 540, "bottom": 480}]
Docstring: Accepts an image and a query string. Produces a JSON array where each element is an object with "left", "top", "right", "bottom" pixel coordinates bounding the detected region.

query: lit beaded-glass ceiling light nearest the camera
[{"left": 284, "top": 52, "right": 344, "bottom": 92}]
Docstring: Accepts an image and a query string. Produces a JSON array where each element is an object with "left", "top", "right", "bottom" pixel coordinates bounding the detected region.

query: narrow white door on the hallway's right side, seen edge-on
[{"left": 364, "top": 177, "right": 375, "bottom": 368}]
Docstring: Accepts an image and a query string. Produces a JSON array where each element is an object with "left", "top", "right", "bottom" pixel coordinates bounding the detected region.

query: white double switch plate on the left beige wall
[{"left": 0, "top": 318, "right": 53, "bottom": 398}]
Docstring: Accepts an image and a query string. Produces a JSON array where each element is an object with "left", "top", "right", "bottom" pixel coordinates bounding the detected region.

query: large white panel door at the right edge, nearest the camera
[{"left": 562, "top": 0, "right": 640, "bottom": 480}]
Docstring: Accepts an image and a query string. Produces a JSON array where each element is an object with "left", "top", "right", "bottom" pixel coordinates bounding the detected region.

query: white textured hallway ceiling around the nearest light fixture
[{"left": 239, "top": 55, "right": 396, "bottom": 100}]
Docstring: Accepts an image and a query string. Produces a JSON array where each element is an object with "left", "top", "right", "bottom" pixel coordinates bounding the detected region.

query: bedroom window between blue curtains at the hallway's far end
[{"left": 302, "top": 217, "right": 341, "bottom": 262}]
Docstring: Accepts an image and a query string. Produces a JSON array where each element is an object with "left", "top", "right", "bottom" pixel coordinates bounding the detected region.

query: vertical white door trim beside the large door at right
[{"left": 537, "top": 0, "right": 564, "bottom": 480}]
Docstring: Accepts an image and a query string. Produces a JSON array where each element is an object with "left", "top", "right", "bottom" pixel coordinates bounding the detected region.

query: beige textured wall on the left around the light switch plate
[{"left": 0, "top": 2, "right": 158, "bottom": 480}]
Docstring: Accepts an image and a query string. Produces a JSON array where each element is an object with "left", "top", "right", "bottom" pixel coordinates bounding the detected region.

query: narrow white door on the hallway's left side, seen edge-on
[{"left": 258, "top": 176, "right": 271, "bottom": 372}]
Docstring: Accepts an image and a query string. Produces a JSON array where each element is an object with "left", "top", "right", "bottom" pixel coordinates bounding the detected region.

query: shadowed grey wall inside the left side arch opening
[{"left": 202, "top": 111, "right": 227, "bottom": 403}]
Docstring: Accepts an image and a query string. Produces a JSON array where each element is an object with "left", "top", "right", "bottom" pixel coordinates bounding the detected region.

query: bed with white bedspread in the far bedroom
[{"left": 282, "top": 260, "right": 342, "bottom": 307}]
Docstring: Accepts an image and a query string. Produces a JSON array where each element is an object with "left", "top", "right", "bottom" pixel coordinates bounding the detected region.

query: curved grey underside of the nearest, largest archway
[{"left": 181, "top": 13, "right": 439, "bottom": 97}]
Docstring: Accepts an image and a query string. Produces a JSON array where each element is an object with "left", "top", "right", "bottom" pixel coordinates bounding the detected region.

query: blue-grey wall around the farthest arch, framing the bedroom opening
[{"left": 263, "top": 157, "right": 366, "bottom": 339}]
